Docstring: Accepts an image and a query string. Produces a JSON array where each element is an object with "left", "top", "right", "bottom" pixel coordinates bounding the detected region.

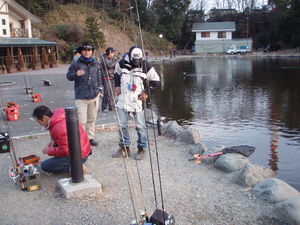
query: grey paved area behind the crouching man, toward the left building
[{"left": 0, "top": 65, "right": 117, "bottom": 138}]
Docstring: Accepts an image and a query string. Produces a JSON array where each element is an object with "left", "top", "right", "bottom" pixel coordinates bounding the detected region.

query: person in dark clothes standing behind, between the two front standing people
[{"left": 101, "top": 47, "right": 118, "bottom": 112}]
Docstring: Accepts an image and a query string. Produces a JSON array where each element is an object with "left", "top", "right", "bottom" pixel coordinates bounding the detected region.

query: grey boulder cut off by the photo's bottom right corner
[{"left": 275, "top": 197, "right": 300, "bottom": 225}]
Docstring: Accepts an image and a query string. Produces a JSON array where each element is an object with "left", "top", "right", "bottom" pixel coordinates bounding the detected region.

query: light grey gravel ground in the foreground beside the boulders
[{"left": 0, "top": 130, "right": 284, "bottom": 225}]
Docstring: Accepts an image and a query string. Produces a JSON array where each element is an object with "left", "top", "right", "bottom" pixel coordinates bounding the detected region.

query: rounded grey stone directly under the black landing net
[{"left": 215, "top": 153, "right": 249, "bottom": 173}]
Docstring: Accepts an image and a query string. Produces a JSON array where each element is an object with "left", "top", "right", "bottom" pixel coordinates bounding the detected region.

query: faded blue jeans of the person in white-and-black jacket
[{"left": 117, "top": 109, "right": 147, "bottom": 148}]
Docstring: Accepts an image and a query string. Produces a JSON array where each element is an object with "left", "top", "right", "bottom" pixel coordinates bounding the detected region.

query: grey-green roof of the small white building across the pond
[{"left": 192, "top": 22, "right": 235, "bottom": 32}]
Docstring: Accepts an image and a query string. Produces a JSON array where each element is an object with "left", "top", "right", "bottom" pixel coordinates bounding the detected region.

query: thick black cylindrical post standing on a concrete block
[{"left": 65, "top": 107, "right": 84, "bottom": 183}]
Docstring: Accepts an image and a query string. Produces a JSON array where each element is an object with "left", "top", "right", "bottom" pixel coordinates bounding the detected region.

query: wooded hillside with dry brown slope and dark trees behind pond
[{"left": 16, "top": 0, "right": 300, "bottom": 59}]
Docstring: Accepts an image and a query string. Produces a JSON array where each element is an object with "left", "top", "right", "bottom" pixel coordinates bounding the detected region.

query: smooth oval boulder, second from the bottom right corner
[{"left": 252, "top": 178, "right": 300, "bottom": 203}]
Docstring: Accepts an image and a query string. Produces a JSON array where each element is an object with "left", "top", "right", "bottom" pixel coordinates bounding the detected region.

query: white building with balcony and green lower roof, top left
[{"left": 0, "top": 0, "right": 58, "bottom": 73}]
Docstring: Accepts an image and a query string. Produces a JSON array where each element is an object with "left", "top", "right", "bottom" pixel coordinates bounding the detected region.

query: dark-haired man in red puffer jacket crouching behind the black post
[{"left": 32, "top": 105, "right": 91, "bottom": 173}]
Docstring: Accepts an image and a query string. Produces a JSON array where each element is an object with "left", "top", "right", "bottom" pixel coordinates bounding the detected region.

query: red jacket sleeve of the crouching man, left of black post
[{"left": 47, "top": 128, "right": 69, "bottom": 157}]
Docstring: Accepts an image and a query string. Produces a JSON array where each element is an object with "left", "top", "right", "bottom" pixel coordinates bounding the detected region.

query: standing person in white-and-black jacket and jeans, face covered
[{"left": 112, "top": 46, "right": 160, "bottom": 160}]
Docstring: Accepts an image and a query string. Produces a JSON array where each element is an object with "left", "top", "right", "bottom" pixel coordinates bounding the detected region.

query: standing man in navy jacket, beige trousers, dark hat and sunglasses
[{"left": 67, "top": 42, "right": 103, "bottom": 146}]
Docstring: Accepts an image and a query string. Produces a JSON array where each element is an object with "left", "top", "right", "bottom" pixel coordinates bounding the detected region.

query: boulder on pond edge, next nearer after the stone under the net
[{"left": 234, "top": 163, "right": 276, "bottom": 187}]
